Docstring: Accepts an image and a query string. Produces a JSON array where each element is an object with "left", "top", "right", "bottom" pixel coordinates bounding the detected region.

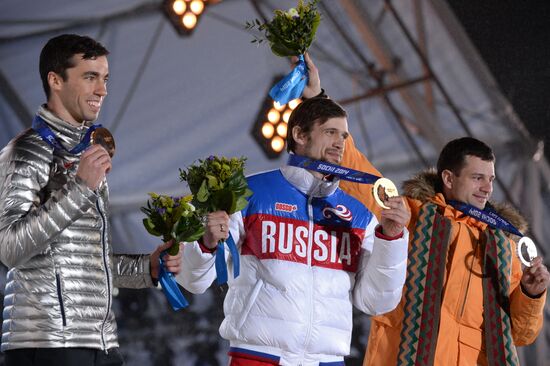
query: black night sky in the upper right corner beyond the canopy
[{"left": 447, "top": 0, "right": 550, "bottom": 157}]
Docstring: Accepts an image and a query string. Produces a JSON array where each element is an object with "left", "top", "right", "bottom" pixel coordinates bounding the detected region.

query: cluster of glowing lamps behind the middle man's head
[{"left": 250, "top": 76, "right": 302, "bottom": 159}]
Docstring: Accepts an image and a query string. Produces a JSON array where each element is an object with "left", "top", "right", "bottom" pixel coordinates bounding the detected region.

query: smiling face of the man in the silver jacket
[{"left": 48, "top": 54, "right": 109, "bottom": 124}]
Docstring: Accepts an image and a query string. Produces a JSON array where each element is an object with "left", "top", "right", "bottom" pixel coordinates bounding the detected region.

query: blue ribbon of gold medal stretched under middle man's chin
[{"left": 287, "top": 154, "right": 380, "bottom": 184}]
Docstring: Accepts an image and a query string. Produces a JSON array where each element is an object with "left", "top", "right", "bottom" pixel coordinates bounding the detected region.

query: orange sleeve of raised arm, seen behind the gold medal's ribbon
[{"left": 340, "top": 136, "right": 382, "bottom": 218}]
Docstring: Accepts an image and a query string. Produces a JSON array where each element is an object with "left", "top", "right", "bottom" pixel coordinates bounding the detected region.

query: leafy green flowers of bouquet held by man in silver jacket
[{"left": 141, "top": 193, "right": 204, "bottom": 255}]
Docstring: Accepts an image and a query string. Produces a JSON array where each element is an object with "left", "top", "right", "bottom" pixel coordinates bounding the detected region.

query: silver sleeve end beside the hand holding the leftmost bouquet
[{"left": 113, "top": 254, "right": 155, "bottom": 289}]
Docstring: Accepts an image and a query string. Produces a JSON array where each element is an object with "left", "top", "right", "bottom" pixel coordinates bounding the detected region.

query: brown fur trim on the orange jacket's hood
[{"left": 403, "top": 168, "right": 528, "bottom": 233}]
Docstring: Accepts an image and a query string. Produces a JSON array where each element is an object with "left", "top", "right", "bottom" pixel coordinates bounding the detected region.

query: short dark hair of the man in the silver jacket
[{"left": 39, "top": 34, "right": 109, "bottom": 99}]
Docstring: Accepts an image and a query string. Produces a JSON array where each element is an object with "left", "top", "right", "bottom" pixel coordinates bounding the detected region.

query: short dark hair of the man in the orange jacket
[{"left": 437, "top": 137, "right": 495, "bottom": 184}]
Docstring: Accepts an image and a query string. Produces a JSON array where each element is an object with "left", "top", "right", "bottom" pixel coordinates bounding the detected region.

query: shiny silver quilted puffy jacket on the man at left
[{"left": 0, "top": 107, "right": 153, "bottom": 351}]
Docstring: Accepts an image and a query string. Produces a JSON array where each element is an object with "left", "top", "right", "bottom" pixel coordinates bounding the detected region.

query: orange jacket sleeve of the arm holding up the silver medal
[{"left": 510, "top": 240, "right": 546, "bottom": 346}]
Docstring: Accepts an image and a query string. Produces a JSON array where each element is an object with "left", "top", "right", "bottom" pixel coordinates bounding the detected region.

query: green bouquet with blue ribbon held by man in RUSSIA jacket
[{"left": 180, "top": 156, "right": 252, "bottom": 285}]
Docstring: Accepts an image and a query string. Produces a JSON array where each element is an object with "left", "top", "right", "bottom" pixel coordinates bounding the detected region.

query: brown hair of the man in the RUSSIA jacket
[{"left": 286, "top": 97, "right": 348, "bottom": 152}]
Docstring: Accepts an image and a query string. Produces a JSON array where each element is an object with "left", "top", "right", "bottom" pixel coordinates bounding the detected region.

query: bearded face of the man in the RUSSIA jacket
[{"left": 295, "top": 117, "right": 349, "bottom": 164}]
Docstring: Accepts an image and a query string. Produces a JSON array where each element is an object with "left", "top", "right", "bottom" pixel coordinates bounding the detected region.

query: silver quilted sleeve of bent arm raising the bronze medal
[{"left": 0, "top": 140, "right": 97, "bottom": 268}]
